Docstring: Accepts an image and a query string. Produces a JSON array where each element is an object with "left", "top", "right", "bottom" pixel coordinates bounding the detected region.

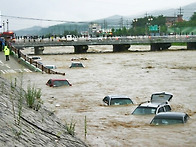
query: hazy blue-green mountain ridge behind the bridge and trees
[{"left": 15, "top": 2, "right": 196, "bottom": 36}]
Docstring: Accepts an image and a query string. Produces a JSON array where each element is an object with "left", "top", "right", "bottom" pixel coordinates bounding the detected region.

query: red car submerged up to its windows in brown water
[{"left": 46, "top": 79, "right": 72, "bottom": 87}]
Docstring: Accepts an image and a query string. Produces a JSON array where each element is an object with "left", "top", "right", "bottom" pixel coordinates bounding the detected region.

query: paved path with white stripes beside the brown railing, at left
[{"left": 0, "top": 52, "right": 32, "bottom": 74}]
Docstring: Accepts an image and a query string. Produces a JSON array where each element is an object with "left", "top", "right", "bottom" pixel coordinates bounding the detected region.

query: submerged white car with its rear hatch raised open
[{"left": 132, "top": 92, "right": 173, "bottom": 115}]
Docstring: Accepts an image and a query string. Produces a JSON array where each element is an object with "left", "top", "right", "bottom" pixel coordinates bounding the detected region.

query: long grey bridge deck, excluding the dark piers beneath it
[{"left": 13, "top": 36, "right": 196, "bottom": 47}]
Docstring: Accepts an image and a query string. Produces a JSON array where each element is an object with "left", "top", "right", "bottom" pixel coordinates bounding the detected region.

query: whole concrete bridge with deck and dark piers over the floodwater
[{"left": 13, "top": 35, "right": 196, "bottom": 54}]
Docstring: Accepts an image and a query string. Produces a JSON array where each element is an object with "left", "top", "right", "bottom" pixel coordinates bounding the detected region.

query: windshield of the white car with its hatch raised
[{"left": 132, "top": 107, "right": 156, "bottom": 115}]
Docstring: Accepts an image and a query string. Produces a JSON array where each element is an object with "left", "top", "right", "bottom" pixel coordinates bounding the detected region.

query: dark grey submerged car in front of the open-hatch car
[{"left": 150, "top": 112, "right": 189, "bottom": 125}]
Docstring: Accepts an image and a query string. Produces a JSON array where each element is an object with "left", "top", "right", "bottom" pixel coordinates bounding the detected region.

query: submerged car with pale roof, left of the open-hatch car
[{"left": 103, "top": 95, "right": 133, "bottom": 106}]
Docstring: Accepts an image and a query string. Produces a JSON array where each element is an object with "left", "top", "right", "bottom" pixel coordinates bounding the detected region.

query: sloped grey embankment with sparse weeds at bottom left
[{"left": 0, "top": 77, "right": 87, "bottom": 147}]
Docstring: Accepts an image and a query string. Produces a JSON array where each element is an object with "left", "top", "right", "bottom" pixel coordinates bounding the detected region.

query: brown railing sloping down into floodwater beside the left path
[{"left": 9, "top": 46, "right": 65, "bottom": 76}]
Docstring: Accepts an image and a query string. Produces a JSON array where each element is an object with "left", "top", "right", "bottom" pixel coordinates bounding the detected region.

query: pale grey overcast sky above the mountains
[{"left": 0, "top": 0, "right": 196, "bottom": 30}]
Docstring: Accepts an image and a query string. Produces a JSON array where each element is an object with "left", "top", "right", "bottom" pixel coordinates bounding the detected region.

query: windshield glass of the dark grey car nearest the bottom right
[{"left": 151, "top": 118, "right": 183, "bottom": 125}]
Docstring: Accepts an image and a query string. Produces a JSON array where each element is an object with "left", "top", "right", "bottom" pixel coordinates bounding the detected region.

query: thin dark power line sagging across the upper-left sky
[{"left": 0, "top": 15, "right": 86, "bottom": 23}]
